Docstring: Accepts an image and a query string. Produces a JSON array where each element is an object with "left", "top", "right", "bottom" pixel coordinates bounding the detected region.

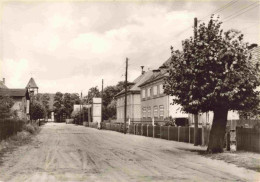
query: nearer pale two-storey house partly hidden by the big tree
[{"left": 139, "top": 58, "right": 188, "bottom": 122}]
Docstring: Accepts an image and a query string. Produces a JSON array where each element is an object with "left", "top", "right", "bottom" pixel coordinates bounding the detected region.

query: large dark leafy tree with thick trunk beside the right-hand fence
[{"left": 164, "top": 17, "right": 260, "bottom": 152}]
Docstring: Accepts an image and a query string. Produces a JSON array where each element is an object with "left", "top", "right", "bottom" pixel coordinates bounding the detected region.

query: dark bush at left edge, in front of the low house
[{"left": 0, "top": 96, "right": 14, "bottom": 119}]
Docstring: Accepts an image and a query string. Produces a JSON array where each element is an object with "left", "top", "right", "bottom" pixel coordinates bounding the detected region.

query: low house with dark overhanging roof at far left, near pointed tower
[{"left": 0, "top": 88, "right": 30, "bottom": 119}]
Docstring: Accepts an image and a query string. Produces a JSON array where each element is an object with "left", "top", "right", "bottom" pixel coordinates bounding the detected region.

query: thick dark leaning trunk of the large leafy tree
[{"left": 207, "top": 107, "right": 228, "bottom": 153}]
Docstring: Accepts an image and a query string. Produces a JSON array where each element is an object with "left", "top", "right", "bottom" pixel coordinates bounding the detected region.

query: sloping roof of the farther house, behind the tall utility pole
[{"left": 115, "top": 71, "right": 153, "bottom": 97}]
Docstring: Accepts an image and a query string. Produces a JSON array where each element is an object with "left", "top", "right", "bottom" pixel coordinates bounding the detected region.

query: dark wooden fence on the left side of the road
[{"left": 0, "top": 119, "right": 25, "bottom": 141}]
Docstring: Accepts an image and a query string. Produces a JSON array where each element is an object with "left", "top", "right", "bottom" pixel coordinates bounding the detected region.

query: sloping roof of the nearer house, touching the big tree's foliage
[{"left": 139, "top": 57, "right": 171, "bottom": 87}]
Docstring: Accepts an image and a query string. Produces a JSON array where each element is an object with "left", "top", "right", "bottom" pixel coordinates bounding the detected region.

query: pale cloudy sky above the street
[{"left": 0, "top": 0, "right": 260, "bottom": 95}]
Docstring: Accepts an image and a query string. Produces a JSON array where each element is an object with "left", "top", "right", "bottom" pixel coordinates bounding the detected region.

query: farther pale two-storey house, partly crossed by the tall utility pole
[{"left": 115, "top": 67, "right": 152, "bottom": 122}]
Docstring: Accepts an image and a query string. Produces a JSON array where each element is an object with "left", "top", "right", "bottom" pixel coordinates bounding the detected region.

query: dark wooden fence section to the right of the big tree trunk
[{"left": 236, "top": 127, "right": 260, "bottom": 153}]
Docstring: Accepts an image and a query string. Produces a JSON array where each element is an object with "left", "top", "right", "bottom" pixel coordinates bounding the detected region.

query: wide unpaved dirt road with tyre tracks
[{"left": 0, "top": 123, "right": 260, "bottom": 182}]
